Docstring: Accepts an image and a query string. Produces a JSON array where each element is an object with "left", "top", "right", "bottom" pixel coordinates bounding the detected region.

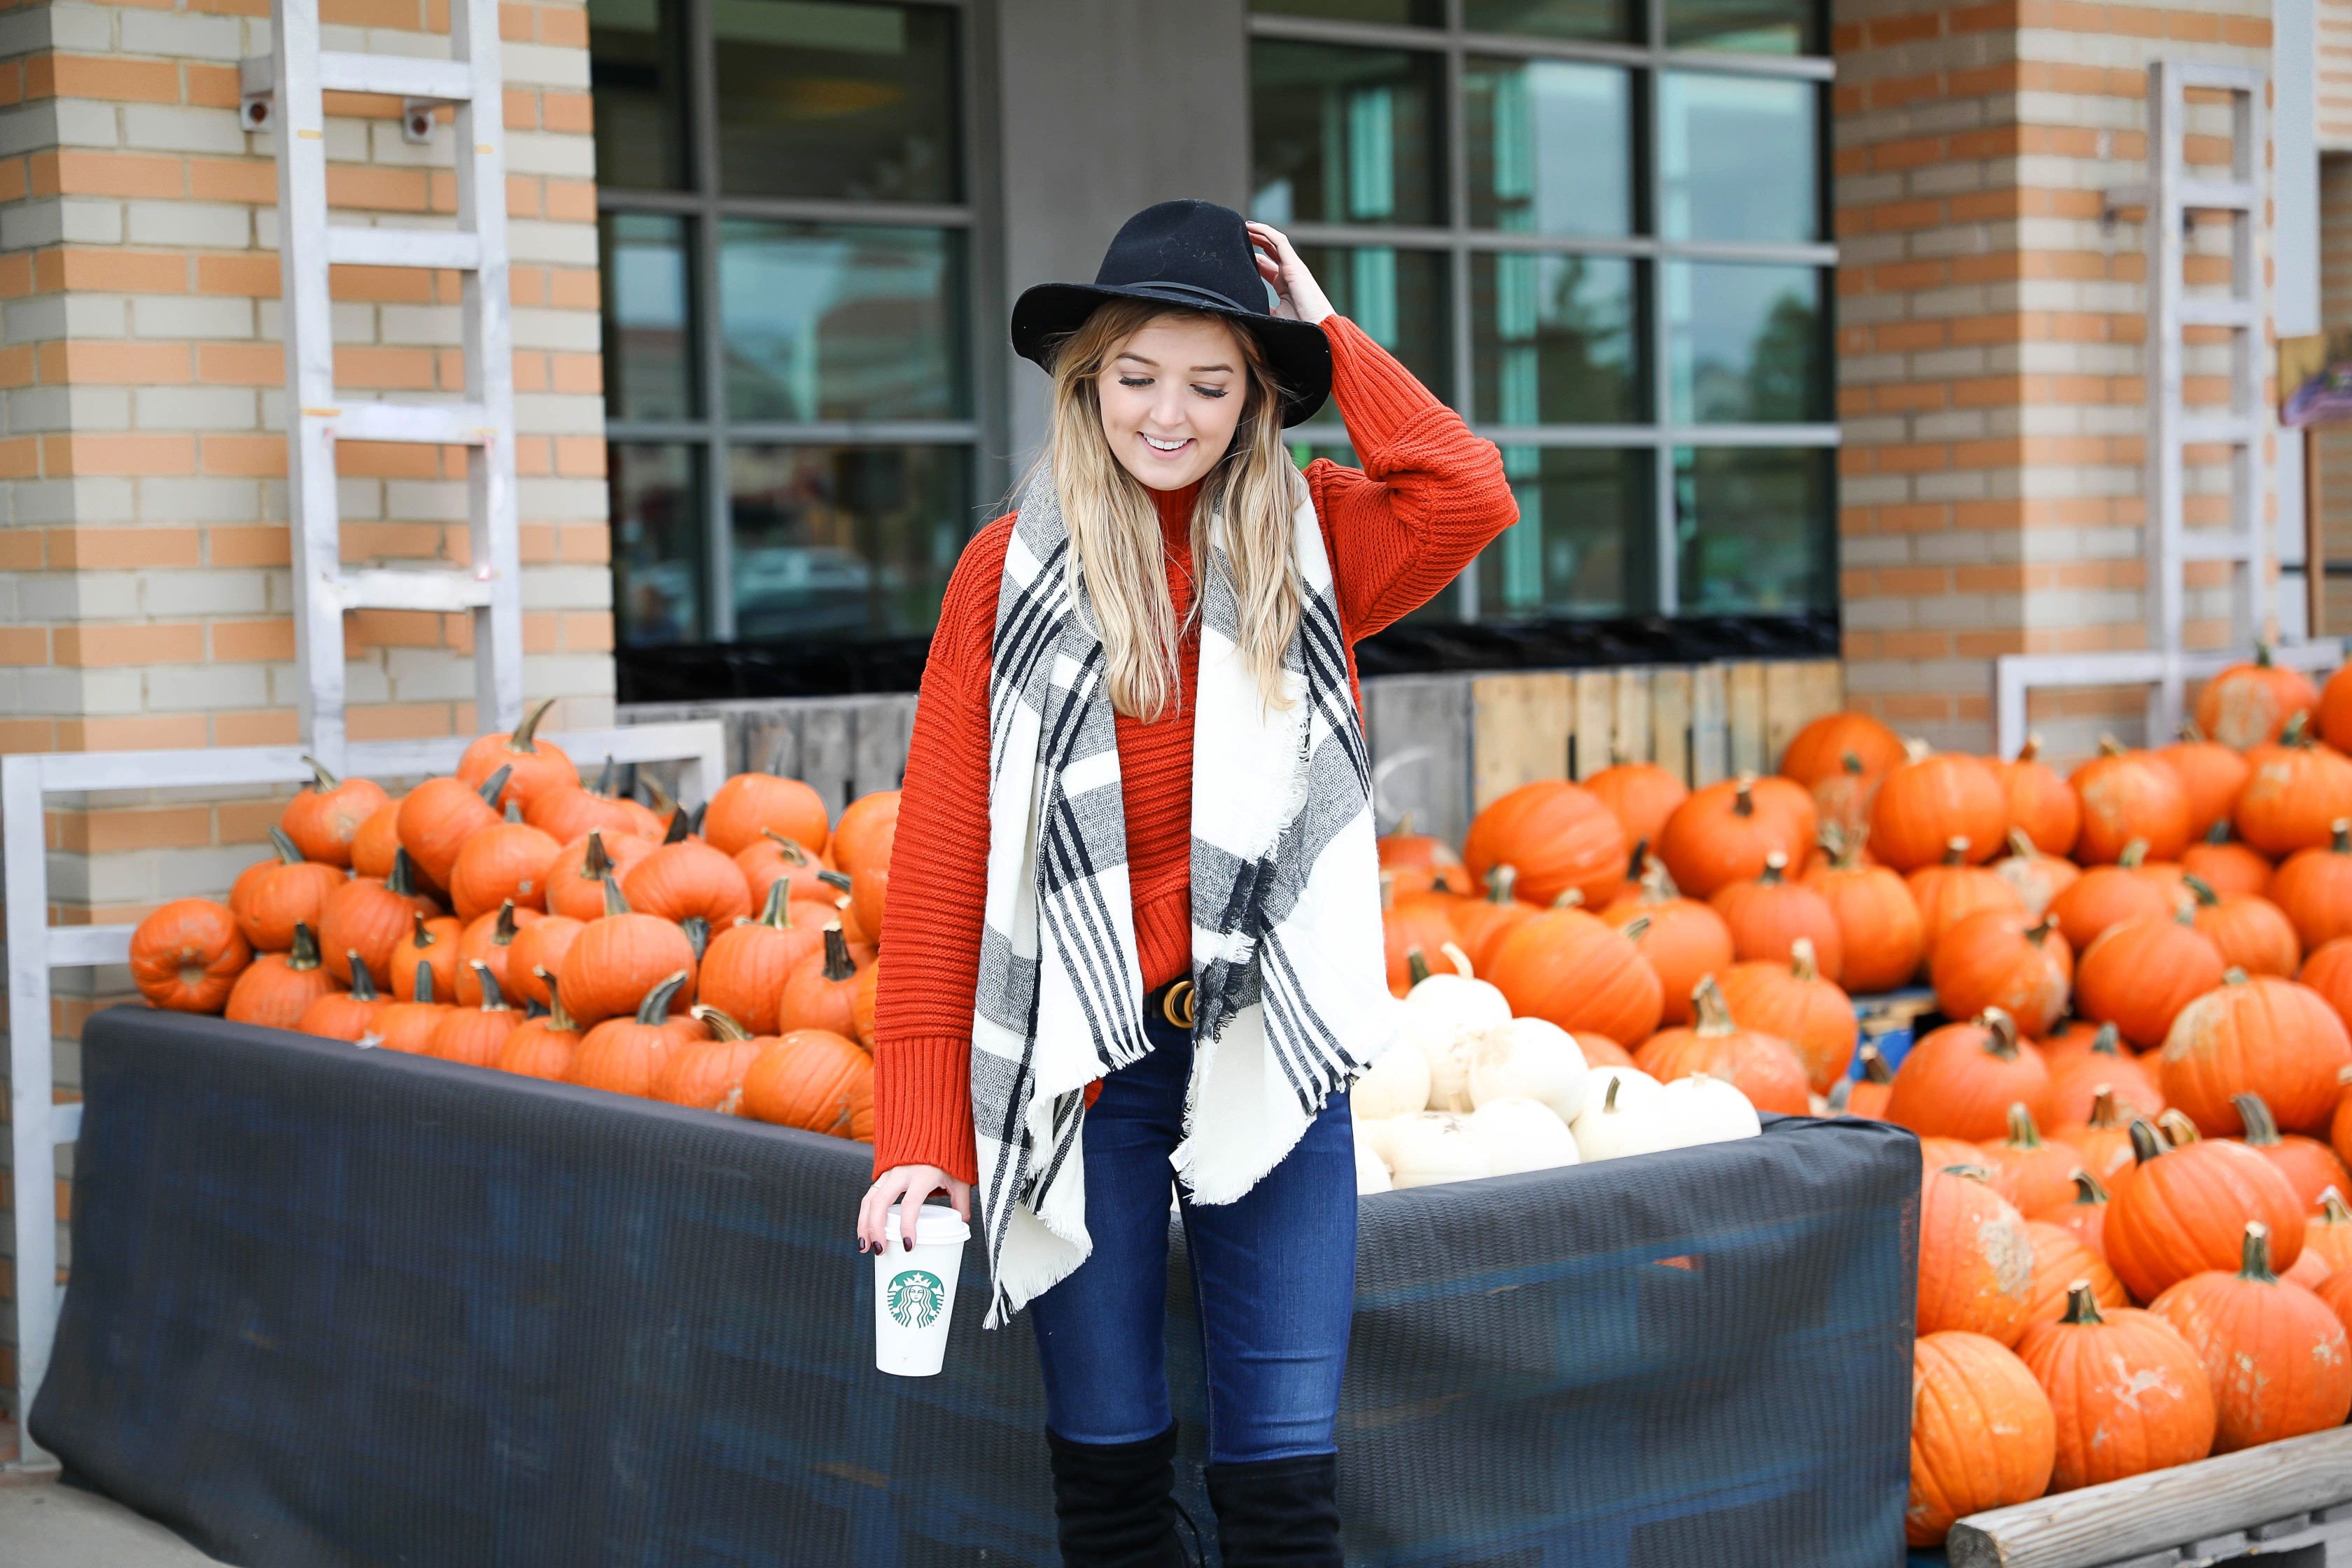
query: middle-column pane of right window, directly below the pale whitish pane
[{"left": 1470, "top": 251, "right": 1651, "bottom": 426}]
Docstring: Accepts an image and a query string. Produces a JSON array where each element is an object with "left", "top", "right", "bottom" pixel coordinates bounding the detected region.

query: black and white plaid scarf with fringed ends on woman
[{"left": 972, "top": 470, "right": 1394, "bottom": 1328}]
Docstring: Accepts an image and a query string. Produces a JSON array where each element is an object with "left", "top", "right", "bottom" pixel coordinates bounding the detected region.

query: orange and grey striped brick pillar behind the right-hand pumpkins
[{"left": 1832, "top": 0, "right": 2269, "bottom": 757}]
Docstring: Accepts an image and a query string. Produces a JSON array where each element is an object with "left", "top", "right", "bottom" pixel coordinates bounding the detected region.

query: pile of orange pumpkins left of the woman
[{"left": 130, "top": 703, "right": 899, "bottom": 1142}]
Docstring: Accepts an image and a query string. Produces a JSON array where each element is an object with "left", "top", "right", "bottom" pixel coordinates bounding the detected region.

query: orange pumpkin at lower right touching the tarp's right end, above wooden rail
[{"left": 1903, "top": 1333, "right": 2058, "bottom": 1547}]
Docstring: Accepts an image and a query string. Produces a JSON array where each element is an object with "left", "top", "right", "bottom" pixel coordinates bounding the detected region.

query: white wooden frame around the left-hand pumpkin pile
[{"left": 0, "top": 720, "right": 727, "bottom": 1469}]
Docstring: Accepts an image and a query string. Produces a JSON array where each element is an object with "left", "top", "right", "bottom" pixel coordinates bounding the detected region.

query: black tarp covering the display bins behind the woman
[{"left": 33, "top": 1009, "right": 1919, "bottom": 1568}]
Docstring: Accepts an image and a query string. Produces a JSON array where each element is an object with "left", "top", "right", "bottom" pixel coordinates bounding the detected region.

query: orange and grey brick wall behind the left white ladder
[{"left": 0, "top": 0, "right": 614, "bottom": 1420}]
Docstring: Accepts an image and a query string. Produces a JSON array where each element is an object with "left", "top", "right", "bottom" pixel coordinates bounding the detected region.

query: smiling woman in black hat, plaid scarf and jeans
[{"left": 858, "top": 202, "right": 1517, "bottom": 1568}]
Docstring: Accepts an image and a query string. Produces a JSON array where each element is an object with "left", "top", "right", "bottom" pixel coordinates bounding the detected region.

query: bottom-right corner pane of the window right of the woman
[{"left": 1674, "top": 447, "right": 1837, "bottom": 616}]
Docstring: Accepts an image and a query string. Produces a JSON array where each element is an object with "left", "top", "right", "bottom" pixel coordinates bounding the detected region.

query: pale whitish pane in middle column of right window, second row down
[{"left": 1463, "top": 59, "right": 1632, "bottom": 235}]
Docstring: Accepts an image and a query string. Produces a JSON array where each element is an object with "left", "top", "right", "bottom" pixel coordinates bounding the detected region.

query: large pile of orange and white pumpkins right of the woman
[{"left": 1357, "top": 656, "right": 2352, "bottom": 1544}]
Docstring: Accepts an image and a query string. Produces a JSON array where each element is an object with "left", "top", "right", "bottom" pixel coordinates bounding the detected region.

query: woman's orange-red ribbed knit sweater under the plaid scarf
[{"left": 875, "top": 315, "right": 1520, "bottom": 1182}]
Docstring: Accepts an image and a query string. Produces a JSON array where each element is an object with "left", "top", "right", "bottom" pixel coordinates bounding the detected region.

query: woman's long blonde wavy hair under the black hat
[{"left": 1040, "top": 299, "right": 1298, "bottom": 722}]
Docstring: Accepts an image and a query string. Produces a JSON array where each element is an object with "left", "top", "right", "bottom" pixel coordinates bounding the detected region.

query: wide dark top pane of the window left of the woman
[{"left": 710, "top": 0, "right": 965, "bottom": 202}]
